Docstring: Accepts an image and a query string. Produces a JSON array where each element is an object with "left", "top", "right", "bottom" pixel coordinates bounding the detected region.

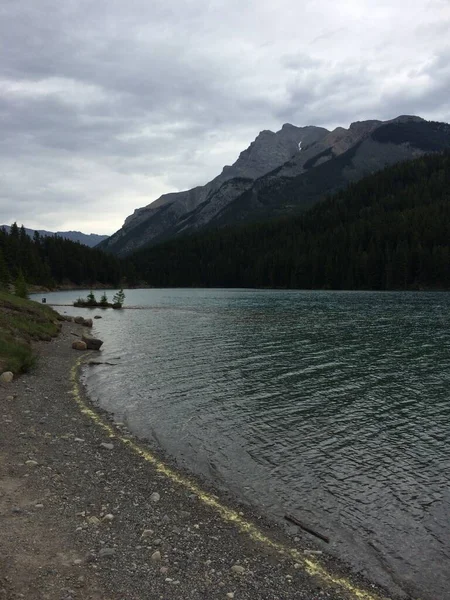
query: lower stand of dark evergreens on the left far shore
[{"left": 0, "top": 223, "right": 135, "bottom": 288}]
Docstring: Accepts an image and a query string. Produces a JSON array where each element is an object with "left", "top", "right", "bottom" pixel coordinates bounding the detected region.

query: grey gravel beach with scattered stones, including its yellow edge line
[{"left": 0, "top": 322, "right": 404, "bottom": 600}]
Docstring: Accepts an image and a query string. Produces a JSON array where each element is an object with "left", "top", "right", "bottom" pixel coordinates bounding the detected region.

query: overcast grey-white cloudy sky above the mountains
[{"left": 0, "top": 0, "right": 450, "bottom": 234}]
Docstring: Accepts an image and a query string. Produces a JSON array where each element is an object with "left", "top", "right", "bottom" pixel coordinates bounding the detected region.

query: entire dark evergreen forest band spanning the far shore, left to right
[{"left": 0, "top": 152, "right": 450, "bottom": 290}]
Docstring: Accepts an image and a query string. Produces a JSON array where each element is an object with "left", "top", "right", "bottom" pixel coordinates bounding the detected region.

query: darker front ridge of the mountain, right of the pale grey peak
[{"left": 210, "top": 118, "right": 450, "bottom": 226}]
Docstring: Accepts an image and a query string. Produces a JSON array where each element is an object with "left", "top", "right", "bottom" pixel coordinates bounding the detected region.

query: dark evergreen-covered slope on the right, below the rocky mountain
[{"left": 131, "top": 152, "right": 450, "bottom": 290}]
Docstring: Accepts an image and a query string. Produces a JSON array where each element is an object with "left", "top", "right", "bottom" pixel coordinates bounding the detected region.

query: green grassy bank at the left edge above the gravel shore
[{"left": 0, "top": 291, "right": 60, "bottom": 375}]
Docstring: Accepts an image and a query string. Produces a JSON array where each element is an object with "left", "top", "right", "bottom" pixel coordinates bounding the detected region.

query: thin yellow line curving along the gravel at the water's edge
[{"left": 71, "top": 358, "right": 388, "bottom": 600}]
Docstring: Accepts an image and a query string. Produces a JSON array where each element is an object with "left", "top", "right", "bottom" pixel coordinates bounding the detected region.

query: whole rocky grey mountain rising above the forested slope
[{"left": 100, "top": 115, "right": 450, "bottom": 256}]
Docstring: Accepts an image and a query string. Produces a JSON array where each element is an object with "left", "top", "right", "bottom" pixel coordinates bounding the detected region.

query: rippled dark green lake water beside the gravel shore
[{"left": 38, "top": 290, "right": 450, "bottom": 600}]
